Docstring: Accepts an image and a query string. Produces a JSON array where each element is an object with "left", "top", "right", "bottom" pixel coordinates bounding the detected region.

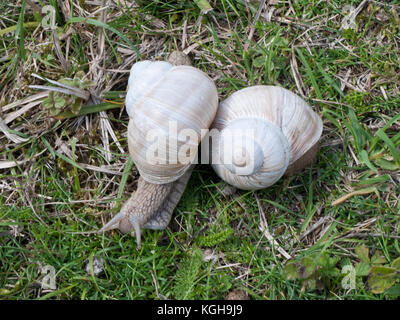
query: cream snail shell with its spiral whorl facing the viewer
[{"left": 212, "top": 86, "right": 322, "bottom": 190}]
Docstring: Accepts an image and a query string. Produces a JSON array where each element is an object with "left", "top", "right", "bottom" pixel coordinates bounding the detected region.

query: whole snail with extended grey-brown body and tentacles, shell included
[{"left": 98, "top": 52, "right": 218, "bottom": 248}]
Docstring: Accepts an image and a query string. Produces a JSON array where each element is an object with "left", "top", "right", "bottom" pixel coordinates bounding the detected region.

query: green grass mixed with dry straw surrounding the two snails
[{"left": 0, "top": 0, "right": 400, "bottom": 299}]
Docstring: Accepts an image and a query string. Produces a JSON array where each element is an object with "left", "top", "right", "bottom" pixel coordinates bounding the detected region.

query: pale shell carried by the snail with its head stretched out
[{"left": 126, "top": 61, "right": 218, "bottom": 184}]
